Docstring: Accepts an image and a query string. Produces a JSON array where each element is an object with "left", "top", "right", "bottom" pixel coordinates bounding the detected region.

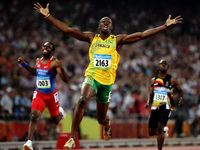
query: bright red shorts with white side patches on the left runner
[{"left": 31, "top": 90, "right": 59, "bottom": 117}]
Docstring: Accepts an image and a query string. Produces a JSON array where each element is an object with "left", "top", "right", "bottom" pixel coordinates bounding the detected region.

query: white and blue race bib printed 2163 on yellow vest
[{"left": 94, "top": 54, "right": 112, "bottom": 68}]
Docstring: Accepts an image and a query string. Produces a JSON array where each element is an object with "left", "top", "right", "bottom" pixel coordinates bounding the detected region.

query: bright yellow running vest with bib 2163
[{"left": 85, "top": 34, "right": 120, "bottom": 85}]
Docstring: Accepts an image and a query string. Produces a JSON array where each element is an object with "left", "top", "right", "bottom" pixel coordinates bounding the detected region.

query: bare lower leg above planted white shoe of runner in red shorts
[{"left": 28, "top": 110, "right": 41, "bottom": 140}]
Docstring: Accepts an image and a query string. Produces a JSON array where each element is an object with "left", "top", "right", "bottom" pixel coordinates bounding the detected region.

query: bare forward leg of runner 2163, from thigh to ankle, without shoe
[{"left": 71, "top": 84, "right": 96, "bottom": 138}]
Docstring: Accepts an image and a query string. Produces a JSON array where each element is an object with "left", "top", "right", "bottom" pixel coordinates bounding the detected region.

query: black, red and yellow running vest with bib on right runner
[{"left": 151, "top": 74, "right": 173, "bottom": 109}]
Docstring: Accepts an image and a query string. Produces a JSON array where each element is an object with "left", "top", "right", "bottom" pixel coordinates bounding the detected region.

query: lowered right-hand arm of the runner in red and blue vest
[{"left": 55, "top": 60, "right": 69, "bottom": 83}]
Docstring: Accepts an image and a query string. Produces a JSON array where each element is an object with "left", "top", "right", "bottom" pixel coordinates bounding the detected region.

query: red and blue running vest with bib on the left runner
[{"left": 36, "top": 57, "right": 55, "bottom": 93}]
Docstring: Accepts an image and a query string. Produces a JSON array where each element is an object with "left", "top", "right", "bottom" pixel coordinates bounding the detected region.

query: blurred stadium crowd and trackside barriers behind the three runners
[{"left": 0, "top": 0, "right": 200, "bottom": 150}]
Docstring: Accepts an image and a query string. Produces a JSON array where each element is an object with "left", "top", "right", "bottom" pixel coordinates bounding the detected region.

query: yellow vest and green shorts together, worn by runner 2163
[{"left": 83, "top": 34, "right": 120, "bottom": 103}]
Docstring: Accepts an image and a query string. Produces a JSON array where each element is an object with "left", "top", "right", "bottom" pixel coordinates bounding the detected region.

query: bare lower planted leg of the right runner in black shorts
[{"left": 157, "top": 123, "right": 165, "bottom": 150}]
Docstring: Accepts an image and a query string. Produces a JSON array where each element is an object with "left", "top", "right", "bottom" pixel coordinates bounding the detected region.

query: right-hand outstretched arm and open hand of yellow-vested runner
[{"left": 118, "top": 15, "right": 183, "bottom": 44}]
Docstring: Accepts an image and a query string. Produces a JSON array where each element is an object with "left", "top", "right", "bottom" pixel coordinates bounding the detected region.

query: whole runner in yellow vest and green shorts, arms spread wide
[{"left": 34, "top": 3, "right": 182, "bottom": 149}]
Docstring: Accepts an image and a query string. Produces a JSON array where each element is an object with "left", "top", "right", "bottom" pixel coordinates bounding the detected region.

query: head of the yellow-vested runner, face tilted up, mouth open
[{"left": 98, "top": 17, "right": 112, "bottom": 34}]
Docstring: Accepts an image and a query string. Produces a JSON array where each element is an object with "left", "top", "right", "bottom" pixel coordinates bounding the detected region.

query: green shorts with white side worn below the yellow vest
[{"left": 82, "top": 77, "right": 112, "bottom": 103}]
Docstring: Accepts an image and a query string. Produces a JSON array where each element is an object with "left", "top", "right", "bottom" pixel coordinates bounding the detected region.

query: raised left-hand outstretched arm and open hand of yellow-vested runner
[{"left": 34, "top": 2, "right": 94, "bottom": 43}]
